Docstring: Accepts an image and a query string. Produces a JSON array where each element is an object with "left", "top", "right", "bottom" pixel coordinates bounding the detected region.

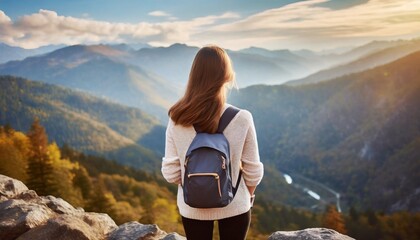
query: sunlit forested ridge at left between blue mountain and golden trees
[{"left": 0, "top": 76, "right": 164, "bottom": 171}]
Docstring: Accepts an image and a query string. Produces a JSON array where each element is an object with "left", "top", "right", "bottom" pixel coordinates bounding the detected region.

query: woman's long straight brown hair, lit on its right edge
[{"left": 168, "top": 46, "right": 235, "bottom": 133}]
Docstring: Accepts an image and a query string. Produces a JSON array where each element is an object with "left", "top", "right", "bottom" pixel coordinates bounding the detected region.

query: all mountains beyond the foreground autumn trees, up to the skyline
[{"left": 0, "top": 40, "right": 420, "bottom": 211}]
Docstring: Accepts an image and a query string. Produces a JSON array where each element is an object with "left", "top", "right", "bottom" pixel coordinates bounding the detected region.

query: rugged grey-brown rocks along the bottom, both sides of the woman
[{"left": 0, "top": 175, "right": 352, "bottom": 240}]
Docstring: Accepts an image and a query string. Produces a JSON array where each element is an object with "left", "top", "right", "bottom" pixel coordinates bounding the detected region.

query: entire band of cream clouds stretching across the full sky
[{"left": 0, "top": 0, "right": 420, "bottom": 49}]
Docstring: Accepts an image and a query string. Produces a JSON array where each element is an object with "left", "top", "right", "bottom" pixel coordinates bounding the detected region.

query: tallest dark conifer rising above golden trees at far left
[{"left": 27, "top": 119, "right": 57, "bottom": 195}]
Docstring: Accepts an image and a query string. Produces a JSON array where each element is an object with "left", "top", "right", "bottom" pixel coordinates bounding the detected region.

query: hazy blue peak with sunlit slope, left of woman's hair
[{"left": 0, "top": 45, "right": 180, "bottom": 121}]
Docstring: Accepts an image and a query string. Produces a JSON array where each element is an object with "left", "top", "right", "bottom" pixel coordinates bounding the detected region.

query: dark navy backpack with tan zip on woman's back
[{"left": 182, "top": 106, "right": 242, "bottom": 208}]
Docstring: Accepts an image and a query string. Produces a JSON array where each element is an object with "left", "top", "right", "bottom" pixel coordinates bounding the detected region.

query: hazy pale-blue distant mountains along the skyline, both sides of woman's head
[{"left": 0, "top": 40, "right": 420, "bottom": 124}]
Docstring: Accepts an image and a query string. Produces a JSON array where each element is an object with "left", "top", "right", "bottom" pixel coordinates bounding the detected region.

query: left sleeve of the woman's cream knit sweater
[{"left": 161, "top": 119, "right": 181, "bottom": 184}]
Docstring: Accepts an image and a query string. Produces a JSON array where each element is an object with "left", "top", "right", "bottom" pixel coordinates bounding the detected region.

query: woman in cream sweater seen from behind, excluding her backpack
[{"left": 162, "top": 46, "right": 263, "bottom": 240}]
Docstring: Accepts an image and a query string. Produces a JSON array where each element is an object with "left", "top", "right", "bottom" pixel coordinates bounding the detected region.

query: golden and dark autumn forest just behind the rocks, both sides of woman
[{"left": 0, "top": 124, "right": 420, "bottom": 240}]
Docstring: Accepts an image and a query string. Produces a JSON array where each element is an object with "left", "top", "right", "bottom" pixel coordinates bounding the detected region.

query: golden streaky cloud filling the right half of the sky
[{"left": 194, "top": 0, "right": 420, "bottom": 48}]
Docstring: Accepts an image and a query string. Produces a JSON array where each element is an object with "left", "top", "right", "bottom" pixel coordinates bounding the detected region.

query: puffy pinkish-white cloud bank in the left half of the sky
[{"left": 0, "top": 9, "right": 238, "bottom": 48}]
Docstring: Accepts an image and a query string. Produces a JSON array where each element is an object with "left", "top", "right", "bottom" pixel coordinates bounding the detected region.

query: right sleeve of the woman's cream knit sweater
[{"left": 241, "top": 112, "right": 264, "bottom": 186}]
